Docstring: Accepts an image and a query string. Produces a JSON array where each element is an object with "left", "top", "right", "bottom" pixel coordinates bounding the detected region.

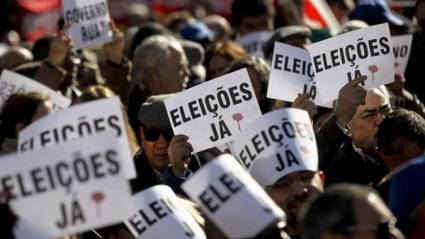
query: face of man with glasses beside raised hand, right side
[{"left": 350, "top": 89, "right": 392, "bottom": 150}]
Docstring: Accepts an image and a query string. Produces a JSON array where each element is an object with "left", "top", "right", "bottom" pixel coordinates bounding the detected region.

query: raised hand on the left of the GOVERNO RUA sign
[{"left": 47, "top": 24, "right": 74, "bottom": 67}]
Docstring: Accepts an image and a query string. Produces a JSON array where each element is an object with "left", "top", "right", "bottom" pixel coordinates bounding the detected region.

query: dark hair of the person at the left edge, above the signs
[{"left": 0, "top": 92, "right": 49, "bottom": 139}]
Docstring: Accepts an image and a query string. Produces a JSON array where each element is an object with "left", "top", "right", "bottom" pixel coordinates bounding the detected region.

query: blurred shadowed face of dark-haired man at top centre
[{"left": 239, "top": 14, "right": 274, "bottom": 36}]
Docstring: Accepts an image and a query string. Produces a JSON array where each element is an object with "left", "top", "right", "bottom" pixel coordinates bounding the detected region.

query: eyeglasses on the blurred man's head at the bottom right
[{"left": 337, "top": 220, "right": 396, "bottom": 239}]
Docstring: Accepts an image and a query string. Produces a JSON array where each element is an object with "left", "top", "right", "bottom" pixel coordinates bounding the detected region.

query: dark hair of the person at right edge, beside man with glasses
[{"left": 376, "top": 109, "right": 425, "bottom": 149}]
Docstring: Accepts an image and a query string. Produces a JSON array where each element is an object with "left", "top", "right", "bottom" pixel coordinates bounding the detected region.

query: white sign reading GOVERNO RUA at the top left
[{"left": 62, "top": 0, "right": 112, "bottom": 50}]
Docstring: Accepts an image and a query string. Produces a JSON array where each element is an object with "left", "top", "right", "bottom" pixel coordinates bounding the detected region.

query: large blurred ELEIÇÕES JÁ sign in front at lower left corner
[{"left": 0, "top": 132, "right": 132, "bottom": 238}]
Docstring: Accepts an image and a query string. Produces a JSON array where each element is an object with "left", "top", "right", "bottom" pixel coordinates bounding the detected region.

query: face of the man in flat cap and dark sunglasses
[{"left": 140, "top": 127, "right": 173, "bottom": 173}]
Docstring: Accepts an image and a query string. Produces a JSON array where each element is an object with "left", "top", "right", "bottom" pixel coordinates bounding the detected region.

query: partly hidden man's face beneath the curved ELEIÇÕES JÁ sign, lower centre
[{"left": 266, "top": 170, "right": 324, "bottom": 225}]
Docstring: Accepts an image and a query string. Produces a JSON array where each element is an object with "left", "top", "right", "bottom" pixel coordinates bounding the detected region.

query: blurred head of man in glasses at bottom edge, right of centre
[{"left": 301, "top": 184, "right": 404, "bottom": 239}]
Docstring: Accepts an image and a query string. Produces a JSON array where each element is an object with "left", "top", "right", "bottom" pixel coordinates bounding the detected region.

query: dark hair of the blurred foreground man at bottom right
[{"left": 300, "top": 184, "right": 373, "bottom": 239}]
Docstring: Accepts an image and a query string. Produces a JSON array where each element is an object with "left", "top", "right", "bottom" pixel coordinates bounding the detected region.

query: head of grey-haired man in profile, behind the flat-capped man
[{"left": 128, "top": 35, "right": 189, "bottom": 142}]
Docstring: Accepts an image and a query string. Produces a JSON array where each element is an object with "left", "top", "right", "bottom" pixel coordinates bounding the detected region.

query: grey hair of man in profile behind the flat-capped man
[{"left": 132, "top": 35, "right": 183, "bottom": 87}]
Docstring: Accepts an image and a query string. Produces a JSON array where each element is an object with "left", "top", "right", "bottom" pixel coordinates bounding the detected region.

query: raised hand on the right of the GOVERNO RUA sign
[{"left": 103, "top": 19, "right": 124, "bottom": 65}]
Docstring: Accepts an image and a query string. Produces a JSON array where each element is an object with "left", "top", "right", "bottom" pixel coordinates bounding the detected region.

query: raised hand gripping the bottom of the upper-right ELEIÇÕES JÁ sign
[{"left": 335, "top": 76, "right": 367, "bottom": 126}]
